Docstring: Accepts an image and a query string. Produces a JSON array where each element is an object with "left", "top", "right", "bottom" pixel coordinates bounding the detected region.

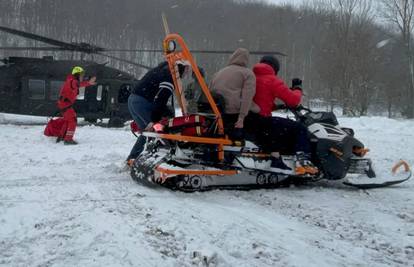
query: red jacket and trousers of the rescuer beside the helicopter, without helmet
[{"left": 57, "top": 75, "right": 91, "bottom": 141}]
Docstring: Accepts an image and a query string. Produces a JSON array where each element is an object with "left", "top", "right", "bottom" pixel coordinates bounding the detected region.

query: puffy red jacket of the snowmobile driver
[{"left": 253, "top": 63, "right": 302, "bottom": 117}]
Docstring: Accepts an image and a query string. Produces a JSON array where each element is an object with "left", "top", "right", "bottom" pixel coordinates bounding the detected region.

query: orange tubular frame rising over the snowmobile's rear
[{"left": 143, "top": 34, "right": 234, "bottom": 162}]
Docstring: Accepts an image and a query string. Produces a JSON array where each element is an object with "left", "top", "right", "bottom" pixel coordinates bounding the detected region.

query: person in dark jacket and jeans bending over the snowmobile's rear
[{"left": 127, "top": 61, "right": 188, "bottom": 166}]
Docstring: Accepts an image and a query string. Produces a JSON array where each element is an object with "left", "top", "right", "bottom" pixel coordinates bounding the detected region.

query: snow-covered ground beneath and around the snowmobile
[{"left": 0, "top": 114, "right": 414, "bottom": 266}]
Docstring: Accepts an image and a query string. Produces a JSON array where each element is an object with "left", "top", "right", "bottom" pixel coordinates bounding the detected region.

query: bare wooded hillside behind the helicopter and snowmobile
[{"left": 0, "top": 0, "right": 414, "bottom": 118}]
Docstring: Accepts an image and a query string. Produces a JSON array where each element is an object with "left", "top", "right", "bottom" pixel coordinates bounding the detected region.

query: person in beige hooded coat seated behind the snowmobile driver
[{"left": 210, "top": 48, "right": 256, "bottom": 138}]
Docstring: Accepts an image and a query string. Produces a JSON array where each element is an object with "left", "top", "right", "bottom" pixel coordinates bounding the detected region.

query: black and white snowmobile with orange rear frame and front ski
[{"left": 131, "top": 34, "right": 411, "bottom": 192}]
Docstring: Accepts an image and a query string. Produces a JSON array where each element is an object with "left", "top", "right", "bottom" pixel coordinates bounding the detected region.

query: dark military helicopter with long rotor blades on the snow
[{"left": 0, "top": 26, "right": 286, "bottom": 127}]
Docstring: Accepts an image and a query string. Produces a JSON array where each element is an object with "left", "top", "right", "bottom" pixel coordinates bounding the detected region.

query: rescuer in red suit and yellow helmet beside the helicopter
[{"left": 56, "top": 66, "right": 96, "bottom": 145}]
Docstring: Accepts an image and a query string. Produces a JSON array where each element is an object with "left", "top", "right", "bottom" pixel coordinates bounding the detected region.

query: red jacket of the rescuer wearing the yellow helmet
[{"left": 57, "top": 74, "right": 91, "bottom": 109}]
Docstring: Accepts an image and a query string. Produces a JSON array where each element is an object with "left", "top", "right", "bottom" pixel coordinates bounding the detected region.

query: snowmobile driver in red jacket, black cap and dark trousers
[{"left": 253, "top": 56, "right": 318, "bottom": 174}]
